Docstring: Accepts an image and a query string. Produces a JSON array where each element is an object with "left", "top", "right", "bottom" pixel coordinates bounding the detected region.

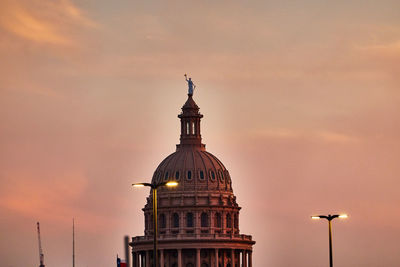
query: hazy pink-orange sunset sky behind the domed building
[{"left": 0, "top": 0, "right": 400, "bottom": 267}]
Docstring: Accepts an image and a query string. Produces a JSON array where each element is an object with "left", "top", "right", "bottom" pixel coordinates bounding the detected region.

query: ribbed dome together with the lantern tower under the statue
[{"left": 152, "top": 95, "right": 232, "bottom": 192}]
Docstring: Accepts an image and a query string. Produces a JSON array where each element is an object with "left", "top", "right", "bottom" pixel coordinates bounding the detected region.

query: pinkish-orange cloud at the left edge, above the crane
[{"left": 0, "top": 171, "right": 88, "bottom": 225}]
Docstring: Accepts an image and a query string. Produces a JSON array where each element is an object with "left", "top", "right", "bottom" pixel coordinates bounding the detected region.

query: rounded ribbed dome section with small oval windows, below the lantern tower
[{"left": 152, "top": 149, "right": 232, "bottom": 191}]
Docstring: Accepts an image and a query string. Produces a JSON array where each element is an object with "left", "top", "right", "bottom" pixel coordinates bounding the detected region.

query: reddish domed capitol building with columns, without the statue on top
[{"left": 130, "top": 88, "right": 255, "bottom": 267}]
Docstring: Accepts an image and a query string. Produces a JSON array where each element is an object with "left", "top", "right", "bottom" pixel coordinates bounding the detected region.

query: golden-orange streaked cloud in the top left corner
[{"left": 0, "top": 0, "right": 96, "bottom": 45}]
